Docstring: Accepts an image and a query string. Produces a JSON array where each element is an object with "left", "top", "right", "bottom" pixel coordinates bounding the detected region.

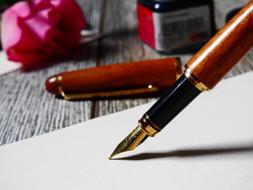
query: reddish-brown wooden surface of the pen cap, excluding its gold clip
[{"left": 46, "top": 58, "right": 181, "bottom": 96}]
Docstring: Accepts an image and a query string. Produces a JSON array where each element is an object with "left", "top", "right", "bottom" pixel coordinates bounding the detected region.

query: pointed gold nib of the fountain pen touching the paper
[{"left": 109, "top": 126, "right": 148, "bottom": 160}]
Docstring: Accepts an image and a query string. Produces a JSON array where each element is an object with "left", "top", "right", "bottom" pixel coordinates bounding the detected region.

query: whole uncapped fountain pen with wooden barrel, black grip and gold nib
[{"left": 110, "top": 0, "right": 253, "bottom": 159}]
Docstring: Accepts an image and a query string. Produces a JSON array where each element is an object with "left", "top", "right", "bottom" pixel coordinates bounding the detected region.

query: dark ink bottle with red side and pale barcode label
[{"left": 137, "top": 0, "right": 216, "bottom": 53}]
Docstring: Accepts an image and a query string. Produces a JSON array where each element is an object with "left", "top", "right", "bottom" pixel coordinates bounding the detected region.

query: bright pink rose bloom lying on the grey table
[{"left": 1, "top": 0, "right": 86, "bottom": 66}]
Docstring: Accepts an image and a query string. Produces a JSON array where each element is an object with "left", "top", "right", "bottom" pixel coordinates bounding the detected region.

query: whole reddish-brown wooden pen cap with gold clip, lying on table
[{"left": 46, "top": 57, "right": 181, "bottom": 100}]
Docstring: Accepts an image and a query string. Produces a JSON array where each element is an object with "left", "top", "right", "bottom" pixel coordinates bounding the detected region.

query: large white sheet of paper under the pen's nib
[{"left": 0, "top": 73, "right": 253, "bottom": 190}]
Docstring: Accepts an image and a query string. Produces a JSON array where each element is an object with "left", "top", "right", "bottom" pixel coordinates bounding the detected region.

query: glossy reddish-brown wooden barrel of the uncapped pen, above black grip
[{"left": 187, "top": 0, "right": 253, "bottom": 89}]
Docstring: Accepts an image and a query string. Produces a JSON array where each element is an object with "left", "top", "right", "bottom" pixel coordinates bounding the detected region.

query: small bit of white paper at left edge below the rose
[{"left": 0, "top": 51, "right": 21, "bottom": 76}]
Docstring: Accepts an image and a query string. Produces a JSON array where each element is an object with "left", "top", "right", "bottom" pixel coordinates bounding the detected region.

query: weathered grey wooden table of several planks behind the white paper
[{"left": 0, "top": 0, "right": 253, "bottom": 145}]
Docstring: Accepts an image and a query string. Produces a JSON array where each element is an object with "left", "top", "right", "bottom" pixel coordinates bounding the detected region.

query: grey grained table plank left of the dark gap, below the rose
[{"left": 0, "top": 0, "right": 101, "bottom": 144}]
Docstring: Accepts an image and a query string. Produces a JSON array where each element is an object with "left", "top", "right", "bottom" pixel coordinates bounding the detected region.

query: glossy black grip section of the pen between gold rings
[{"left": 146, "top": 75, "right": 201, "bottom": 129}]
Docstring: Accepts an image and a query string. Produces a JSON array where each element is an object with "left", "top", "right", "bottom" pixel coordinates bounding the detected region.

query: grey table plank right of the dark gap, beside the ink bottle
[{"left": 95, "top": 0, "right": 160, "bottom": 117}]
